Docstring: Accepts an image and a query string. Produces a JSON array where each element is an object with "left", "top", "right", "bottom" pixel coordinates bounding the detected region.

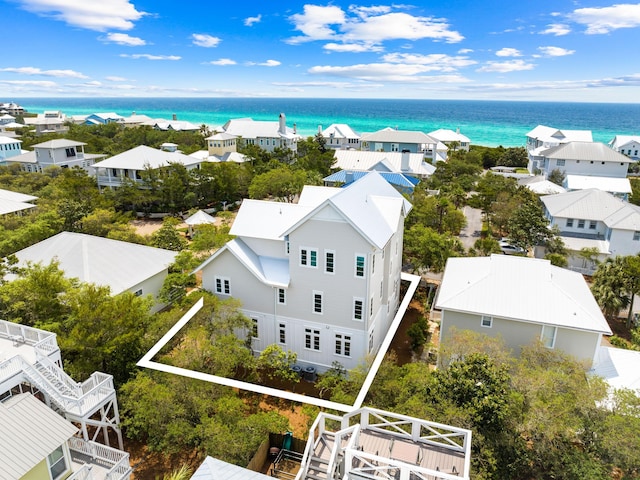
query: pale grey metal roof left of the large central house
[{"left": 10, "top": 232, "right": 177, "bottom": 295}]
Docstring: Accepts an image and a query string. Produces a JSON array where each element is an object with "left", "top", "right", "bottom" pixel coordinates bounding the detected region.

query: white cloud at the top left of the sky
[{"left": 15, "top": 0, "right": 147, "bottom": 32}]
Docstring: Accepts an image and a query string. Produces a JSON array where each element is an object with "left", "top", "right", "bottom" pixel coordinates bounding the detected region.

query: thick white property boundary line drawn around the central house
[{"left": 137, "top": 273, "right": 420, "bottom": 413}]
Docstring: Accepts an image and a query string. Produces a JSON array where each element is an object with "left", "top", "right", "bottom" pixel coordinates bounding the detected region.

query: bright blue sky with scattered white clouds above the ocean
[{"left": 0, "top": 0, "right": 640, "bottom": 103}]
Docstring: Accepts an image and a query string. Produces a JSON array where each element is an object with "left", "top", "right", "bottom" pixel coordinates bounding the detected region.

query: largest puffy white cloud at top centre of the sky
[{"left": 287, "top": 5, "right": 464, "bottom": 44}]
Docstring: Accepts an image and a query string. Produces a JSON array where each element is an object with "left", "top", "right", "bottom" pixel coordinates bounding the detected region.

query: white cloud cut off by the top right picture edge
[{"left": 568, "top": 3, "right": 640, "bottom": 35}]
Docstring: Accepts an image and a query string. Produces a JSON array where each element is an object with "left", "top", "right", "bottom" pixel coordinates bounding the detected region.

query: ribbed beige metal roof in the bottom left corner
[{"left": 0, "top": 393, "right": 78, "bottom": 480}]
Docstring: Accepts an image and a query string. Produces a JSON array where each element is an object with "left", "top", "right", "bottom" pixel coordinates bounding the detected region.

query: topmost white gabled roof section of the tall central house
[{"left": 282, "top": 172, "right": 411, "bottom": 248}]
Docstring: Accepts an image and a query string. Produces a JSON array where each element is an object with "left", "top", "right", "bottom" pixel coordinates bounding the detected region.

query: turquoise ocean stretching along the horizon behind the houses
[{"left": 8, "top": 97, "right": 640, "bottom": 147}]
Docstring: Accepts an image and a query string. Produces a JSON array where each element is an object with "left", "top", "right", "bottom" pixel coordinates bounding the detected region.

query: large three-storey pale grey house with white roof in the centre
[{"left": 198, "top": 172, "right": 411, "bottom": 371}]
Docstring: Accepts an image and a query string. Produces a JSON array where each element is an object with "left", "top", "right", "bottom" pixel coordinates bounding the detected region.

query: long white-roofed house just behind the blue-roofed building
[{"left": 332, "top": 150, "right": 436, "bottom": 178}]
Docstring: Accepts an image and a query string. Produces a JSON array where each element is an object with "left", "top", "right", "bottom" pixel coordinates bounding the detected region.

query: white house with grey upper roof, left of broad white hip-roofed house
[{"left": 10, "top": 138, "right": 104, "bottom": 172}]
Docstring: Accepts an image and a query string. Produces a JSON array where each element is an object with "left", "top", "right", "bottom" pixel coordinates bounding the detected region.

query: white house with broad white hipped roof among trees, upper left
[{"left": 93, "top": 145, "right": 202, "bottom": 188}]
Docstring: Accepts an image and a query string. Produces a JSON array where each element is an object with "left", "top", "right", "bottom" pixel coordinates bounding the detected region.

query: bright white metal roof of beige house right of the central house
[{"left": 436, "top": 255, "right": 611, "bottom": 335}]
